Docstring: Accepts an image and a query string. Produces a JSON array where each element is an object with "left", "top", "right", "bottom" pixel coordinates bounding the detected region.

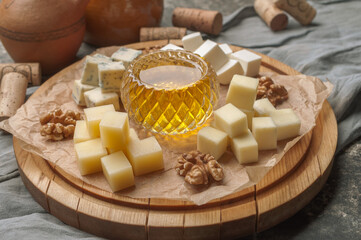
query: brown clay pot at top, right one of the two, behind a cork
[{"left": 85, "top": 0, "right": 163, "bottom": 46}]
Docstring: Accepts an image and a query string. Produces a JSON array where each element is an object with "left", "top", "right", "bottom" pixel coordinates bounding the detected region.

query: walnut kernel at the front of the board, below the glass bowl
[{"left": 175, "top": 151, "right": 224, "bottom": 185}]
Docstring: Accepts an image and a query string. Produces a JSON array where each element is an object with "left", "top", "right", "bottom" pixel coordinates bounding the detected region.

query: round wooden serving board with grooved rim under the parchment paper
[{"left": 13, "top": 40, "right": 337, "bottom": 239}]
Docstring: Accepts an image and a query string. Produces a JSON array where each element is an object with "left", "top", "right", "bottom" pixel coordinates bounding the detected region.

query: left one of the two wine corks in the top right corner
[{"left": 254, "top": 0, "right": 288, "bottom": 31}]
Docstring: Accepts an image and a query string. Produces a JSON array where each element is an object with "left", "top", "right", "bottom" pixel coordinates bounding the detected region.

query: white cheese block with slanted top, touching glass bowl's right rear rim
[{"left": 194, "top": 40, "right": 228, "bottom": 71}]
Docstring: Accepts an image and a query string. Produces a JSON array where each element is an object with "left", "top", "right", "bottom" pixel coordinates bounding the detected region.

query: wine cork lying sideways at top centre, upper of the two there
[{"left": 172, "top": 7, "right": 222, "bottom": 35}]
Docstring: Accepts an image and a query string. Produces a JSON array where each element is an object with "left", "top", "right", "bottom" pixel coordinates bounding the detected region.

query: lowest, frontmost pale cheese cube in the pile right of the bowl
[{"left": 231, "top": 130, "right": 258, "bottom": 164}]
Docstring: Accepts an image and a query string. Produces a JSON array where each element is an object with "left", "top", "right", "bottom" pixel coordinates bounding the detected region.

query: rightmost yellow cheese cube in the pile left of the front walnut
[{"left": 126, "top": 137, "right": 164, "bottom": 176}]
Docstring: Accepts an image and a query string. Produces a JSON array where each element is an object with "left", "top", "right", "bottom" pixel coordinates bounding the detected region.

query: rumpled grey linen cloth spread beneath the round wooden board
[{"left": 0, "top": 0, "right": 361, "bottom": 239}]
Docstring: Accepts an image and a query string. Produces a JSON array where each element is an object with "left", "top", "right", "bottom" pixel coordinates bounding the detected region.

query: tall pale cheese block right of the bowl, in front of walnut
[{"left": 226, "top": 75, "right": 258, "bottom": 110}]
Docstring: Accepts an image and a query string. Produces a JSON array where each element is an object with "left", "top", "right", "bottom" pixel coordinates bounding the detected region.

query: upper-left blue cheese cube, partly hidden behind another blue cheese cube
[{"left": 81, "top": 56, "right": 111, "bottom": 86}]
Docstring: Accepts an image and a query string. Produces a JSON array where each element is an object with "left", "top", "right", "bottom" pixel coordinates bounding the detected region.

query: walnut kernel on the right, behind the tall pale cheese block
[{"left": 257, "top": 76, "right": 288, "bottom": 106}]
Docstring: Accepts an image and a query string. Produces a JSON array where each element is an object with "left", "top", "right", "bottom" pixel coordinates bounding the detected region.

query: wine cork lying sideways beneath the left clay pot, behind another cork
[{"left": 0, "top": 63, "right": 41, "bottom": 86}]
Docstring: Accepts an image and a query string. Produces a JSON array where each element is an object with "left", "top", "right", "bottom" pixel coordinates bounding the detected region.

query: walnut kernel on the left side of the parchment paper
[{"left": 40, "top": 108, "right": 81, "bottom": 141}]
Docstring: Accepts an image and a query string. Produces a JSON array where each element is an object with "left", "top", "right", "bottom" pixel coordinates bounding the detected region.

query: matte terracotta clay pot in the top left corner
[{"left": 0, "top": 0, "right": 88, "bottom": 74}]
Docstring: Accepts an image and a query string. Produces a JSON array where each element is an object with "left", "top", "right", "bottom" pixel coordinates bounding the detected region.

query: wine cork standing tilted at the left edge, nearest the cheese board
[{"left": 0, "top": 72, "right": 28, "bottom": 120}]
